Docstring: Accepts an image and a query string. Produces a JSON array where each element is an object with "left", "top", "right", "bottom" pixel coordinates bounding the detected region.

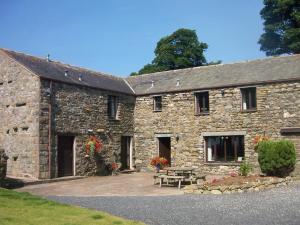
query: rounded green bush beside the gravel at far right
[{"left": 258, "top": 140, "right": 296, "bottom": 177}]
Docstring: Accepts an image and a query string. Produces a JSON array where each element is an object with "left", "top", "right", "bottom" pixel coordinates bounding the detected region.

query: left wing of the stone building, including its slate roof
[{"left": 0, "top": 50, "right": 135, "bottom": 179}]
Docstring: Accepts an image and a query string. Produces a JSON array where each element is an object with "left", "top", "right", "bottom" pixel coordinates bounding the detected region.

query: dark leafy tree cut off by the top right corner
[{"left": 258, "top": 0, "right": 300, "bottom": 56}]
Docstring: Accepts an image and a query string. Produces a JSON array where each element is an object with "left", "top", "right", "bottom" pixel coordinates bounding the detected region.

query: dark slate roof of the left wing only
[{"left": 1, "top": 49, "right": 134, "bottom": 95}]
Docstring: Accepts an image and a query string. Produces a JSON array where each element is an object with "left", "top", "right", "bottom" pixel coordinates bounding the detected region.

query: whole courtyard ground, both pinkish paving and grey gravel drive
[{"left": 18, "top": 173, "right": 300, "bottom": 225}]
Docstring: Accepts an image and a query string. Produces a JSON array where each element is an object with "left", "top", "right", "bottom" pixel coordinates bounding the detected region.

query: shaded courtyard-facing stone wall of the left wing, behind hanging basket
[{"left": 40, "top": 80, "right": 135, "bottom": 178}]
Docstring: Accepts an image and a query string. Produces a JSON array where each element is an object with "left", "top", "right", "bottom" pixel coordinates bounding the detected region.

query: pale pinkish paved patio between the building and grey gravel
[{"left": 17, "top": 173, "right": 183, "bottom": 196}]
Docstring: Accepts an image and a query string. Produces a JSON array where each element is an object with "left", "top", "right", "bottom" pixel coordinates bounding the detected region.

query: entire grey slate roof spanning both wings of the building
[{"left": 0, "top": 49, "right": 300, "bottom": 95}]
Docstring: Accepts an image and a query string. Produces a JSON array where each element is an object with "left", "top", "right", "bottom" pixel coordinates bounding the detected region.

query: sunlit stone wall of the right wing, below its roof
[{"left": 134, "top": 83, "right": 300, "bottom": 174}]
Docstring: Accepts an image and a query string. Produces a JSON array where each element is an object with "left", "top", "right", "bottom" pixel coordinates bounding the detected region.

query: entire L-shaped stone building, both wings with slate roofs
[{"left": 0, "top": 49, "right": 300, "bottom": 179}]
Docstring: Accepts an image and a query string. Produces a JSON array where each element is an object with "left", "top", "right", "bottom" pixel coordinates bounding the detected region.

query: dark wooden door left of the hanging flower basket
[{"left": 57, "top": 136, "right": 74, "bottom": 177}]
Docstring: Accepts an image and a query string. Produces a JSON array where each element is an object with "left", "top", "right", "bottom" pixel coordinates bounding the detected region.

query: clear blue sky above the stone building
[{"left": 0, "top": 0, "right": 265, "bottom": 76}]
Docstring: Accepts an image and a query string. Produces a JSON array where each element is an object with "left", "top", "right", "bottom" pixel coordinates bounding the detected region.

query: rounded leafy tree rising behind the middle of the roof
[{"left": 131, "top": 29, "right": 220, "bottom": 76}]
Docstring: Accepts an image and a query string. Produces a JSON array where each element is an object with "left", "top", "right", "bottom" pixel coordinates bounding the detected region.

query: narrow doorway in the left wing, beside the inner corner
[{"left": 120, "top": 136, "right": 132, "bottom": 170}]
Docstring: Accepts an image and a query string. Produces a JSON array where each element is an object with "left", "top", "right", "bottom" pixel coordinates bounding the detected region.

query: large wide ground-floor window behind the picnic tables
[{"left": 205, "top": 136, "right": 244, "bottom": 162}]
